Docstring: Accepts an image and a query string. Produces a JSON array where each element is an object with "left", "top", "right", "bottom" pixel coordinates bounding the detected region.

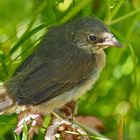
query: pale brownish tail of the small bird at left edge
[{"left": 0, "top": 84, "right": 14, "bottom": 113}]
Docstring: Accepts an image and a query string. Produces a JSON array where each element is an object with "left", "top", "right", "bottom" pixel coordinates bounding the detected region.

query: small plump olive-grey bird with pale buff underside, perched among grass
[{"left": 0, "top": 17, "right": 123, "bottom": 135}]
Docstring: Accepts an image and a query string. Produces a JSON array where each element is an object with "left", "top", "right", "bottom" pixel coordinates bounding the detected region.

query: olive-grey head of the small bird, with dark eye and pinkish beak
[{"left": 72, "top": 17, "right": 123, "bottom": 53}]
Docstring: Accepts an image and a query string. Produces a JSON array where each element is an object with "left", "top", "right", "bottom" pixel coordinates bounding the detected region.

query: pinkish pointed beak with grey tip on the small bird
[{"left": 96, "top": 34, "right": 124, "bottom": 48}]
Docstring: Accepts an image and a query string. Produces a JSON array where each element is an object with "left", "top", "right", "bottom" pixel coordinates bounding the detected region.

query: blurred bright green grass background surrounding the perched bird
[{"left": 0, "top": 0, "right": 140, "bottom": 140}]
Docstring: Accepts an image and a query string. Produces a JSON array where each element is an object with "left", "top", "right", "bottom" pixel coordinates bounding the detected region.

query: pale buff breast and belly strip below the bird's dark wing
[{"left": 32, "top": 50, "right": 105, "bottom": 114}]
